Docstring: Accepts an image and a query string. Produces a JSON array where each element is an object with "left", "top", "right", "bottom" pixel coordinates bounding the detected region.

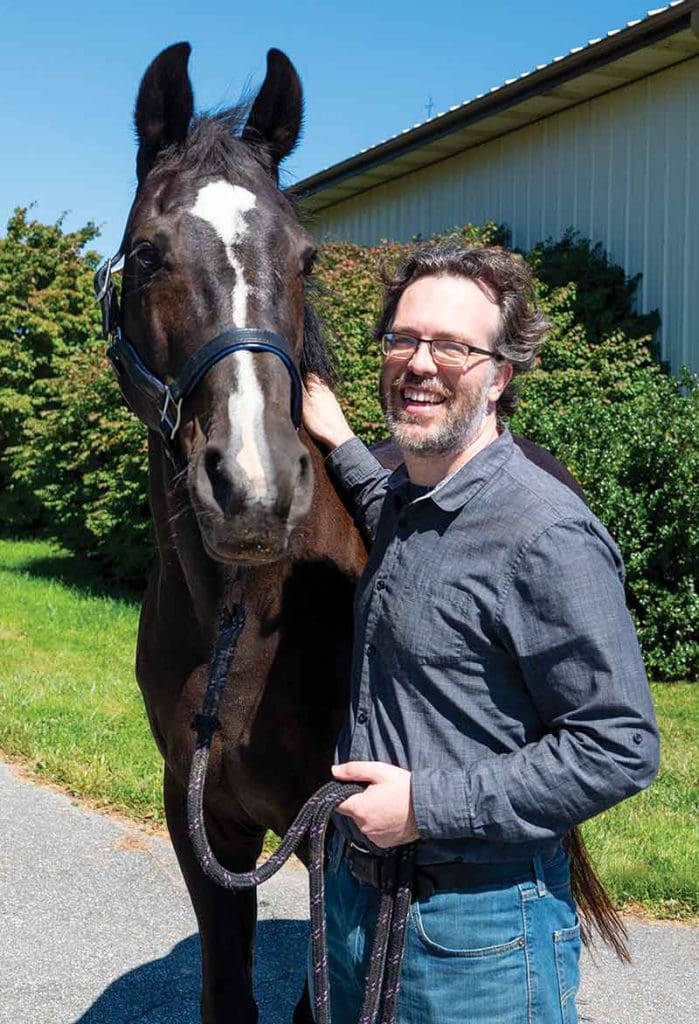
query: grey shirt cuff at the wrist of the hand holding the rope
[{"left": 410, "top": 768, "right": 473, "bottom": 839}]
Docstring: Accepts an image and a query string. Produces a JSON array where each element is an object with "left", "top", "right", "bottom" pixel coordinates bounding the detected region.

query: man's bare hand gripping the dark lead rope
[{"left": 333, "top": 761, "right": 420, "bottom": 848}]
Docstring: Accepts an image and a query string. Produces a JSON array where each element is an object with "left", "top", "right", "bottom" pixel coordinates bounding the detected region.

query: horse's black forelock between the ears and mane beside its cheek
[{"left": 158, "top": 107, "right": 338, "bottom": 386}]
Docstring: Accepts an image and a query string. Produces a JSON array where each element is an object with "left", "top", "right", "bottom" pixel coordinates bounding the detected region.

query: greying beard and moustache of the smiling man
[{"left": 383, "top": 372, "right": 495, "bottom": 456}]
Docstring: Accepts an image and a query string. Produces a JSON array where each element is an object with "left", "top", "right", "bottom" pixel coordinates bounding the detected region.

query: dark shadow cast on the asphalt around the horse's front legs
[{"left": 74, "top": 920, "right": 308, "bottom": 1024}]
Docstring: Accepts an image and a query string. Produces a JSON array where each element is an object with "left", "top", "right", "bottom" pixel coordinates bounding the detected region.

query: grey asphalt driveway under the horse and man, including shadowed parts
[{"left": 0, "top": 763, "right": 699, "bottom": 1024}]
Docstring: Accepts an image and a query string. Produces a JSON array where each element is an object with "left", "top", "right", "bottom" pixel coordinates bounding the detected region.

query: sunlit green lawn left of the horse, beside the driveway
[{"left": 0, "top": 540, "right": 163, "bottom": 822}]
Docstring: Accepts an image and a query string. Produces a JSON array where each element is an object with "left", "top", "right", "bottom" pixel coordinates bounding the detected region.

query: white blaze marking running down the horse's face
[{"left": 189, "top": 186, "right": 271, "bottom": 498}]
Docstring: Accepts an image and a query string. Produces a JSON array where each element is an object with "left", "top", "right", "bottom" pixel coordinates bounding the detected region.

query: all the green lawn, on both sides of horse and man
[{"left": 0, "top": 539, "right": 699, "bottom": 918}]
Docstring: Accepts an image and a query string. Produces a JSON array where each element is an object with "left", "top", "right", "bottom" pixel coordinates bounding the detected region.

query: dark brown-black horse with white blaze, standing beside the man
[{"left": 110, "top": 43, "right": 630, "bottom": 1024}]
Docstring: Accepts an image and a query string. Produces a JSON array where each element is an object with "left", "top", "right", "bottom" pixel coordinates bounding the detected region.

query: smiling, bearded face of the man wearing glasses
[{"left": 381, "top": 276, "right": 507, "bottom": 456}]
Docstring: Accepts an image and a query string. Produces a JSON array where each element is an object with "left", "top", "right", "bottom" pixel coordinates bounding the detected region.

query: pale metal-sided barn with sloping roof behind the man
[{"left": 294, "top": 0, "right": 699, "bottom": 371}]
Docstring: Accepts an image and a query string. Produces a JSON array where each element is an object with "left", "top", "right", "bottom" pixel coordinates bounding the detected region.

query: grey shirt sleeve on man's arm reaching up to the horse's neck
[{"left": 325, "top": 437, "right": 391, "bottom": 545}]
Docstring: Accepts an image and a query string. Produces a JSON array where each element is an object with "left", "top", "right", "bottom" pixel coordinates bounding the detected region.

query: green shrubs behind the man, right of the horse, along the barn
[{"left": 316, "top": 223, "right": 699, "bottom": 680}]
